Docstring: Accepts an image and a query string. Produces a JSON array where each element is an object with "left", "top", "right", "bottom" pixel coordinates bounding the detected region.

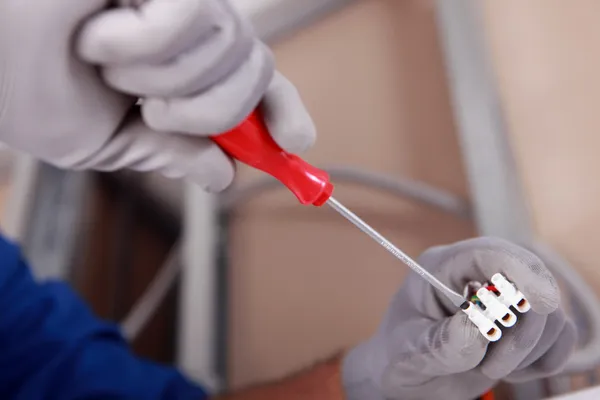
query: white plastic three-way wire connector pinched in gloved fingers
[{"left": 463, "top": 273, "right": 531, "bottom": 342}]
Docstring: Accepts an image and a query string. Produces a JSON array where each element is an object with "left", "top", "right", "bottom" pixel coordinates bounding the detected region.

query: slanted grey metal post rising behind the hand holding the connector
[{"left": 436, "top": 0, "right": 552, "bottom": 400}]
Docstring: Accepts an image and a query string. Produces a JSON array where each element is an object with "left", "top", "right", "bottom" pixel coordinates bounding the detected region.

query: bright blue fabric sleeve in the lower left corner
[{"left": 0, "top": 236, "right": 207, "bottom": 400}]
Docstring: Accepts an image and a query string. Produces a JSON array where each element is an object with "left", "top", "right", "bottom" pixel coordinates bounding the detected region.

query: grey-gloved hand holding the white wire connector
[{"left": 343, "top": 238, "right": 576, "bottom": 400}]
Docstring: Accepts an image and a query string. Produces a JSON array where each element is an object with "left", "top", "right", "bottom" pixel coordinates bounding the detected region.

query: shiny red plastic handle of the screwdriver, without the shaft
[{"left": 212, "top": 111, "right": 333, "bottom": 206}]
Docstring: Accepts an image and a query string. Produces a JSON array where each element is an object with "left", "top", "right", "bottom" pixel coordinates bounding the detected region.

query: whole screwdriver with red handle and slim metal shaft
[{"left": 212, "top": 111, "right": 468, "bottom": 309}]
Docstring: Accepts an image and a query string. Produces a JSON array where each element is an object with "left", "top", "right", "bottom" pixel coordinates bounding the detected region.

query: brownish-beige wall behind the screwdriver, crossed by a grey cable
[{"left": 230, "top": 0, "right": 473, "bottom": 386}]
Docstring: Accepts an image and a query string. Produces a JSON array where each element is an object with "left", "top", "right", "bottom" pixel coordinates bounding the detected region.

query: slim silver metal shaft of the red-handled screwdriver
[{"left": 327, "top": 197, "right": 466, "bottom": 308}]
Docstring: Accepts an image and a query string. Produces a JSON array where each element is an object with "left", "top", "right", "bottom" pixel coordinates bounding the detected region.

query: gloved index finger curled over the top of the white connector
[{"left": 420, "top": 238, "right": 560, "bottom": 315}]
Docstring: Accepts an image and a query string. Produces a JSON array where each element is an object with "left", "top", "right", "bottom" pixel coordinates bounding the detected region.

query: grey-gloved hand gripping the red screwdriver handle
[{"left": 0, "top": 0, "right": 315, "bottom": 191}]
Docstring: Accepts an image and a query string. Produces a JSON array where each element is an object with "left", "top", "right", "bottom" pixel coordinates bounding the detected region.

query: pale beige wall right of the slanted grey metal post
[{"left": 483, "top": 0, "right": 600, "bottom": 288}]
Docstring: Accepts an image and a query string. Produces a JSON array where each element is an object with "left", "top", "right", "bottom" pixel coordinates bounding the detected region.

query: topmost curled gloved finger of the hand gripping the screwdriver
[{"left": 78, "top": 0, "right": 235, "bottom": 64}]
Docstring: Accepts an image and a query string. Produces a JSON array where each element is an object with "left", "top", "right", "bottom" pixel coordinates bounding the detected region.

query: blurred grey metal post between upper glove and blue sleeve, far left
[{"left": 3, "top": 155, "right": 90, "bottom": 280}]
